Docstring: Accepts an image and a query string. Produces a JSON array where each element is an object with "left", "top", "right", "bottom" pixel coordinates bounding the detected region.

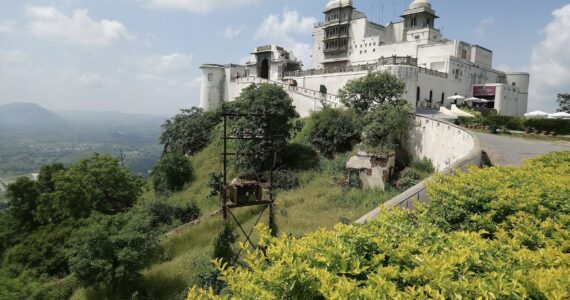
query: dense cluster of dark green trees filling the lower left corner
[{"left": 0, "top": 155, "right": 158, "bottom": 299}]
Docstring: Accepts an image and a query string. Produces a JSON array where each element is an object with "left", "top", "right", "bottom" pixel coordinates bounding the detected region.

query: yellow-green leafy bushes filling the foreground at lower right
[{"left": 188, "top": 152, "right": 570, "bottom": 299}]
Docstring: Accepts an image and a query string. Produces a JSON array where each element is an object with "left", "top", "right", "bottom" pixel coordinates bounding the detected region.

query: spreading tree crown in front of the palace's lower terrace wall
[{"left": 338, "top": 71, "right": 406, "bottom": 114}]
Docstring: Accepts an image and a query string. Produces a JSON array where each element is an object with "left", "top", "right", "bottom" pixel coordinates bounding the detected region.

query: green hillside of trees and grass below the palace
[{"left": 0, "top": 74, "right": 425, "bottom": 299}]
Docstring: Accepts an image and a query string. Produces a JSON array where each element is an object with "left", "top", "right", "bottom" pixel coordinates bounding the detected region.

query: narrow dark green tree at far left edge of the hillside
[{"left": 8, "top": 177, "right": 41, "bottom": 232}]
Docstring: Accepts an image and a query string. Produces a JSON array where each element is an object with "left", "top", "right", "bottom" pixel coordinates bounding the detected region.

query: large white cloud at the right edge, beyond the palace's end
[{"left": 529, "top": 4, "right": 570, "bottom": 111}]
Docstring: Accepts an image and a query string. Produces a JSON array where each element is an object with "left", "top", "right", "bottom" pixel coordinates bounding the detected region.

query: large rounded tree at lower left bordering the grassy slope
[{"left": 67, "top": 212, "right": 161, "bottom": 291}]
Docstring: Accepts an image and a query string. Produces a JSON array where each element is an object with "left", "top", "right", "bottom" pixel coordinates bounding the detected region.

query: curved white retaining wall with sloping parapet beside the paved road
[{"left": 356, "top": 116, "right": 482, "bottom": 224}]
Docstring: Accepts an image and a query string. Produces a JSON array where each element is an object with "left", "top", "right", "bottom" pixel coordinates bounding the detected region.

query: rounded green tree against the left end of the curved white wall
[{"left": 363, "top": 102, "right": 412, "bottom": 151}]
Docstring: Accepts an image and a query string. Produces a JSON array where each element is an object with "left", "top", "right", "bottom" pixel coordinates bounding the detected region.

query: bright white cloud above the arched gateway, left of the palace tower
[{"left": 255, "top": 9, "right": 317, "bottom": 66}]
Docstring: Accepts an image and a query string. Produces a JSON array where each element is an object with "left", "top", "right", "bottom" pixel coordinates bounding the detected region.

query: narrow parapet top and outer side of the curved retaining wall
[{"left": 356, "top": 115, "right": 482, "bottom": 224}]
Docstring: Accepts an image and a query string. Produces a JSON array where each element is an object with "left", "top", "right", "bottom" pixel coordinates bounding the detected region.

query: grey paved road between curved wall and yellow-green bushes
[{"left": 477, "top": 133, "right": 570, "bottom": 166}]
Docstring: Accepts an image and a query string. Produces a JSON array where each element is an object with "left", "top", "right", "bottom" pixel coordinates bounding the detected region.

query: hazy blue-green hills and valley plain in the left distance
[{"left": 0, "top": 103, "right": 167, "bottom": 177}]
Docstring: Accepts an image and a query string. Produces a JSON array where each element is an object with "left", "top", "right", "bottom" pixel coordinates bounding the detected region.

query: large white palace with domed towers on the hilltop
[{"left": 200, "top": 0, "right": 530, "bottom": 116}]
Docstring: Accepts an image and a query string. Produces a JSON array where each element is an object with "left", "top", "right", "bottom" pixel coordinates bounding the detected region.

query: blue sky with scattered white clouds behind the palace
[{"left": 0, "top": 0, "right": 570, "bottom": 115}]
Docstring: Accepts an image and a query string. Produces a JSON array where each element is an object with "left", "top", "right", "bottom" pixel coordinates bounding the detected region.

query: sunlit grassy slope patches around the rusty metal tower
[{"left": 72, "top": 141, "right": 397, "bottom": 299}]
